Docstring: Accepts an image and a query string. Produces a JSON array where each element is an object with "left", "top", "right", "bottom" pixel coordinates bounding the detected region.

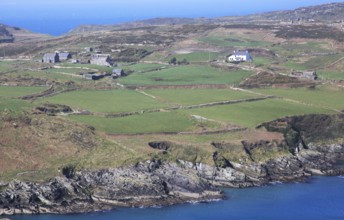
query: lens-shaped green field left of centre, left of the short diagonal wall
[{"left": 39, "top": 90, "right": 165, "bottom": 113}]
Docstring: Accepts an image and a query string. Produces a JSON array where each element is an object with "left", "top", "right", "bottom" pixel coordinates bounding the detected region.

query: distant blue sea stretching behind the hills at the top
[{"left": 0, "top": 0, "right": 341, "bottom": 36}]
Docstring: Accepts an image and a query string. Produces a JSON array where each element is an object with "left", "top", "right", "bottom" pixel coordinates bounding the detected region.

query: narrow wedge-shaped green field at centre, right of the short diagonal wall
[{"left": 145, "top": 89, "right": 258, "bottom": 105}]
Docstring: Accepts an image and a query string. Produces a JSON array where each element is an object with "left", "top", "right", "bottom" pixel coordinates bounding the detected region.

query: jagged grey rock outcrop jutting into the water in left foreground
[{"left": 0, "top": 161, "right": 223, "bottom": 215}]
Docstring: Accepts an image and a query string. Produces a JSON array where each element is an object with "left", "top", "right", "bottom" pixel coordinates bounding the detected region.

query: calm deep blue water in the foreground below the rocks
[{"left": 13, "top": 177, "right": 344, "bottom": 220}]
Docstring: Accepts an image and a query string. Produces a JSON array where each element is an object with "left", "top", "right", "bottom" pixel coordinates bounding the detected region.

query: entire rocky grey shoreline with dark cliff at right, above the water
[{"left": 0, "top": 115, "right": 344, "bottom": 215}]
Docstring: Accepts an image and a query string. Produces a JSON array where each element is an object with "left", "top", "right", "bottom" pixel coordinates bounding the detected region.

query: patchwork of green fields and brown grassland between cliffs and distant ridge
[{"left": 0, "top": 2, "right": 344, "bottom": 180}]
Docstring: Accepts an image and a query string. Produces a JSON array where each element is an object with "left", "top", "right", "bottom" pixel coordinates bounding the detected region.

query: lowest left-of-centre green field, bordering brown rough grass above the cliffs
[{"left": 70, "top": 112, "right": 193, "bottom": 134}]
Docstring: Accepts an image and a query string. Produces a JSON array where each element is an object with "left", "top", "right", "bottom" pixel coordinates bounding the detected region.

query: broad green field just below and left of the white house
[{"left": 118, "top": 65, "right": 252, "bottom": 85}]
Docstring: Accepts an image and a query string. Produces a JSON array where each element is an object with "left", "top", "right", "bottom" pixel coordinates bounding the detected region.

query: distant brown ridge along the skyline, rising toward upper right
[{"left": 68, "top": 2, "right": 344, "bottom": 34}]
